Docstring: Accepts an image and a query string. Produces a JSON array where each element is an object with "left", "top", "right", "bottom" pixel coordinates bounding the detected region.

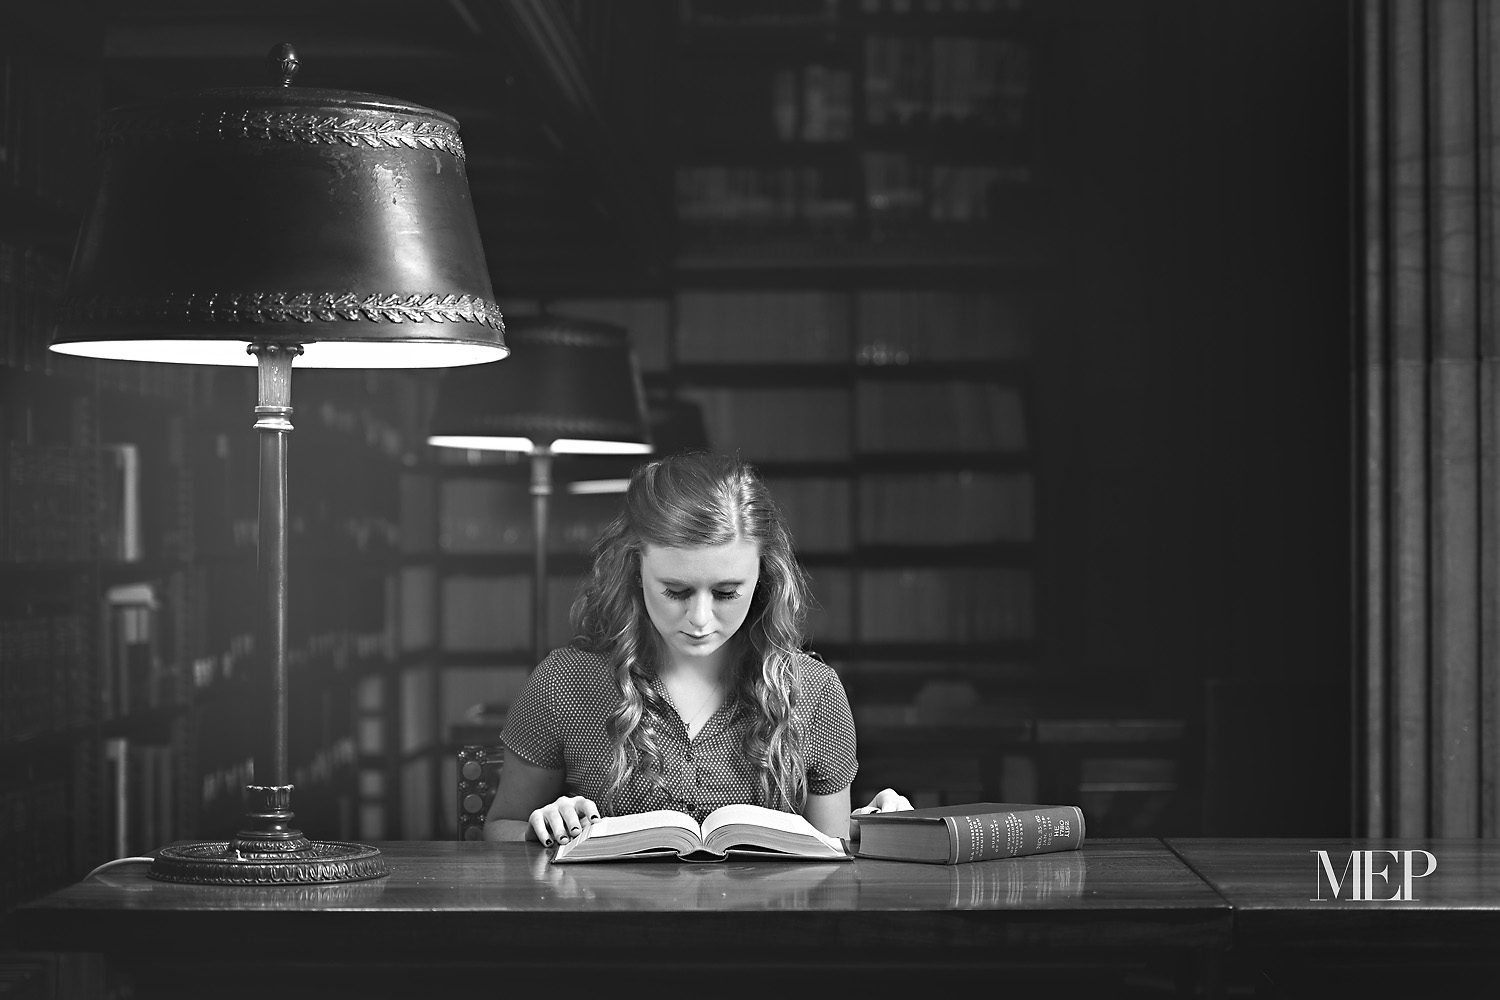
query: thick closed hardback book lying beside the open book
[{"left": 857, "top": 802, "right": 1083, "bottom": 865}]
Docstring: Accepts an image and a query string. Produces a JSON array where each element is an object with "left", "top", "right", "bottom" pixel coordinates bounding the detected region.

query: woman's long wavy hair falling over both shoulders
[{"left": 572, "top": 451, "right": 812, "bottom": 811}]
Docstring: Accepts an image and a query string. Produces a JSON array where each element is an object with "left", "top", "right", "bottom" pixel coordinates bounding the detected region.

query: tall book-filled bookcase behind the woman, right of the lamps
[{"left": 656, "top": 0, "right": 1182, "bottom": 834}]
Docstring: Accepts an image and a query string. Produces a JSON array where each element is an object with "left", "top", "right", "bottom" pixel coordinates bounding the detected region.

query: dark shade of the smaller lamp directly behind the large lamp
[{"left": 428, "top": 315, "right": 651, "bottom": 454}]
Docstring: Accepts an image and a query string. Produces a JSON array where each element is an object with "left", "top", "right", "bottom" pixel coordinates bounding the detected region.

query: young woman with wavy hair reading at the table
[{"left": 485, "top": 453, "right": 911, "bottom": 846}]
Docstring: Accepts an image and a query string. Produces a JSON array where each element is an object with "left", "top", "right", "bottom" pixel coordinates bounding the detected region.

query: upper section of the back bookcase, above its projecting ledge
[{"left": 675, "top": 0, "right": 1044, "bottom": 265}]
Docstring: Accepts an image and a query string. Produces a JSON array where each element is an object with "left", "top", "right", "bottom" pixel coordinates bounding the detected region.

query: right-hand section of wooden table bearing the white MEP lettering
[{"left": 1164, "top": 838, "right": 1500, "bottom": 997}]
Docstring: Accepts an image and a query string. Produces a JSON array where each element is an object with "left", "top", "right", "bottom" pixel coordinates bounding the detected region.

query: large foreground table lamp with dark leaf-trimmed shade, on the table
[{"left": 51, "top": 45, "right": 507, "bottom": 885}]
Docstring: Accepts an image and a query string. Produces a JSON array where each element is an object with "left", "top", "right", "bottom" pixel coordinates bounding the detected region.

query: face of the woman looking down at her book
[{"left": 641, "top": 538, "right": 761, "bottom": 660}]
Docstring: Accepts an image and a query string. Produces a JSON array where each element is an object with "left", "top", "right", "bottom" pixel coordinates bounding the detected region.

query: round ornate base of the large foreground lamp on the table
[{"left": 146, "top": 784, "right": 390, "bottom": 886}]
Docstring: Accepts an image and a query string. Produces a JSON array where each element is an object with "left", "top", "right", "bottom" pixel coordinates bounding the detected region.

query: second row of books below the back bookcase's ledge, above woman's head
[{"left": 683, "top": 381, "right": 1029, "bottom": 462}]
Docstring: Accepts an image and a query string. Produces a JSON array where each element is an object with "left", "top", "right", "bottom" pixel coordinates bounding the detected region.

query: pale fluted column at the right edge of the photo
[{"left": 1355, "top": 0, "right": 1500, "bottom": 837}]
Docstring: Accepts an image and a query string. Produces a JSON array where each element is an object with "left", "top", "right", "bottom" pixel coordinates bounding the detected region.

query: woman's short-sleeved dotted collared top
[{"left": 500, "top": 646, "right": 858, "bottom": 822}]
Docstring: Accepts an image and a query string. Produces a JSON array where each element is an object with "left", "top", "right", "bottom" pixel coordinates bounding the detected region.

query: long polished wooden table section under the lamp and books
[{"left": 15, "top": 840, "right": 1230, "bottom": 997}]
